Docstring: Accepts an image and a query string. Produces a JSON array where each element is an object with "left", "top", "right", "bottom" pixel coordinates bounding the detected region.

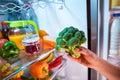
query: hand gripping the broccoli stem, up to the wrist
[{"left": 68, "top": 47, "right": 99, "bottom": 68}]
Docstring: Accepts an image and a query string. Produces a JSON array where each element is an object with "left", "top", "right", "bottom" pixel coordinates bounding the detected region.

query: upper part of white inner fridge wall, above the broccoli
[{"left": 33, "top": 0, "right": 87, "bottom": 36}]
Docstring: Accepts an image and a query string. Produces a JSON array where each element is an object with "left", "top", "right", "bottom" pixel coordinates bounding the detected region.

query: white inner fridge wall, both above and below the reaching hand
[{"left": 33, "top": 0, "right": 88, "bottom": 80}]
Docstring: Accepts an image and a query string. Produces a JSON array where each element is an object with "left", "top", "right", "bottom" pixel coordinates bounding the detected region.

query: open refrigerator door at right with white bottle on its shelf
[{"left": 96, "top": 0, "right": 120, "bottom": 80}]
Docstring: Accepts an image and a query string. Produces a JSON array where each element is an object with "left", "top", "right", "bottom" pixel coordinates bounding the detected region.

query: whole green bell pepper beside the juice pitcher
[{"left": 0, "top": 41, "right": 20, "bottom": 60}]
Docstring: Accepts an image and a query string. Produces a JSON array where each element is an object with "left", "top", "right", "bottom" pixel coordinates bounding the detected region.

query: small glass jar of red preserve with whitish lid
[{"left": 22, "top": 34, "right": 42, "bottom": 55}]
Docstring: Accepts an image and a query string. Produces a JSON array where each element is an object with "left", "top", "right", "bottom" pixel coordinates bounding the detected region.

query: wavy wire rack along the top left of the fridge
[{"left": 0, "top": 0, "right": 65, "bottom": 13}]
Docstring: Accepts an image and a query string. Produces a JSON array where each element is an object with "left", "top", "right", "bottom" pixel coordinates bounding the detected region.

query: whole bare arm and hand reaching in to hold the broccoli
[{"left": 69, "top": 47, "right": 120, "bottom": 80}]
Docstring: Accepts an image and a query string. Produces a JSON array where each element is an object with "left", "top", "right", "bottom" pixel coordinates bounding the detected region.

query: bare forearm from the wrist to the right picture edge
[{"left": 93, "top": 58, "right": 120, "bottom": 80}]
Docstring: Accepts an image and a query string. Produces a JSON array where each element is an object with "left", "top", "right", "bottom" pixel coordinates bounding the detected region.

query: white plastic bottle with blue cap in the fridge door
[{"left": 109, "top": 13, "right": 120, "bottom": 56}]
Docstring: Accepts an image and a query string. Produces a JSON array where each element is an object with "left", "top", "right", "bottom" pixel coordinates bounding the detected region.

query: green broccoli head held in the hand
[{"left": 55, "top": 26, "right": 86, "bottom": 58}]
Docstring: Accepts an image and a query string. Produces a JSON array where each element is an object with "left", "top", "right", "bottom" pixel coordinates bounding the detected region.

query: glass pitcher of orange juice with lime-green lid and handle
[{"left": 2, "top": 20, "right": 38, "bottom": 50}]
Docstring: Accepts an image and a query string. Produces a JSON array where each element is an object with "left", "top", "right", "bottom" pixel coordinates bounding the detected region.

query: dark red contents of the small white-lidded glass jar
[{"left": 25, "top": 43, "right": 40, "bottom": 55}]
